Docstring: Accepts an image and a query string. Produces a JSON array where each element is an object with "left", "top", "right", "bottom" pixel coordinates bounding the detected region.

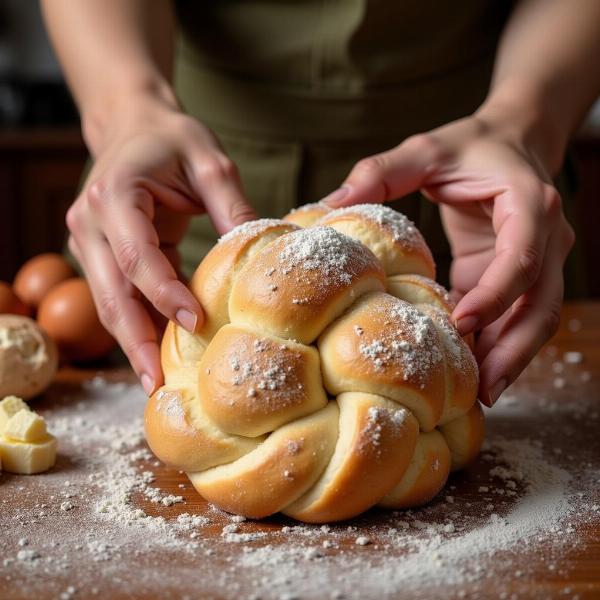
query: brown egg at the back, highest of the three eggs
[{"left": 13, "top": 252, "right": 75, "bottom": 309}]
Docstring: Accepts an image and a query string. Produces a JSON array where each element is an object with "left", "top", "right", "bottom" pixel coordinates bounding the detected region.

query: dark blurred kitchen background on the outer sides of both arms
[{"left": 0, "top": 0, "right": 600, "bottom": 297}]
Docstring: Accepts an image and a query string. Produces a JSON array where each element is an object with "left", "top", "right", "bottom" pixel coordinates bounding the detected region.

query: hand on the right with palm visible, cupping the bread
[{"left": 325, "top": 111, "right": 574, "bottom": 406}]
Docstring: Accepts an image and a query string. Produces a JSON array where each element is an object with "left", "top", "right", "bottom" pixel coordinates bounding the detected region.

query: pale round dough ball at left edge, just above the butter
[{"left": 0, "top": 315, "right": 58, "bottom": 400}]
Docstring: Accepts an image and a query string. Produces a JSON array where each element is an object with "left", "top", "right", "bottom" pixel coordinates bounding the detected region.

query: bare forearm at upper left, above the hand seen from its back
[{"left": 42, "top": 0, "right": 176, "bottom": 153}]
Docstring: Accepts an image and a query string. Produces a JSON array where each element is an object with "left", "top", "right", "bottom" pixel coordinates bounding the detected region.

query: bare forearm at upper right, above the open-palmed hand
[{"left": 479, "top": 0, "right": 600, "bottom": 174}]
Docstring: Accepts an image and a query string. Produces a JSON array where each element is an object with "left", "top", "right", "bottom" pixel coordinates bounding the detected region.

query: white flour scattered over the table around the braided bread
[{"left": 0, "top": 357, "right": 600, "bottom": 600}]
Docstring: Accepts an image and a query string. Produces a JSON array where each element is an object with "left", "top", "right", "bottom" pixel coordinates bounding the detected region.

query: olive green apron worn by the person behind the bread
[{"left": 175, "top": 0, "right": 584, "bottom": 296}]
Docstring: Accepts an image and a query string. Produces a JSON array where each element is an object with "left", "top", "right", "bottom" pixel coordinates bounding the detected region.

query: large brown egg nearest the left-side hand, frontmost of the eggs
[{"left": 37, "top": 277, "right": 116, "bottom": 361}]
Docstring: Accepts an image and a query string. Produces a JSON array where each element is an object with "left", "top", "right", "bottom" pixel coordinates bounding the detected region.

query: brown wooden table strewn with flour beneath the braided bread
[{"left": 0, "top": 303, "right": 600, "bottom": 600}]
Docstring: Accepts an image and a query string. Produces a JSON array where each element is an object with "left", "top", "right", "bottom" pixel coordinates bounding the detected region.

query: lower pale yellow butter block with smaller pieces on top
[{"left": 0, "top": 434, "right": 58, "bottom": 475}]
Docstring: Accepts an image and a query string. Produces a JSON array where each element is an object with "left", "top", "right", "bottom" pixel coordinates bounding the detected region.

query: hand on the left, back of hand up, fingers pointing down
[{"left": 67, "top": 97, "right": 255, "bottom": 394}]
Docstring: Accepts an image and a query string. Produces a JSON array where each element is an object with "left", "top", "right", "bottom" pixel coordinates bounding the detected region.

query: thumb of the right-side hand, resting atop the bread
[{"left": 323, "top": 134, "right": 447, "bottom": 208}]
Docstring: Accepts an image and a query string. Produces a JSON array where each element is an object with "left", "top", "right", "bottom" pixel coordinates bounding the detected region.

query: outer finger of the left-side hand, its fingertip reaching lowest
[{"left": 79, "top": 231, "right": 163, "bottom": 394}]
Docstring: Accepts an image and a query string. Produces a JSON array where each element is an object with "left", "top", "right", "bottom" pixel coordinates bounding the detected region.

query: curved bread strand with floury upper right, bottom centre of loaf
[{"left": 282, "top": 392, "right": 419, "bottom": 523}]
